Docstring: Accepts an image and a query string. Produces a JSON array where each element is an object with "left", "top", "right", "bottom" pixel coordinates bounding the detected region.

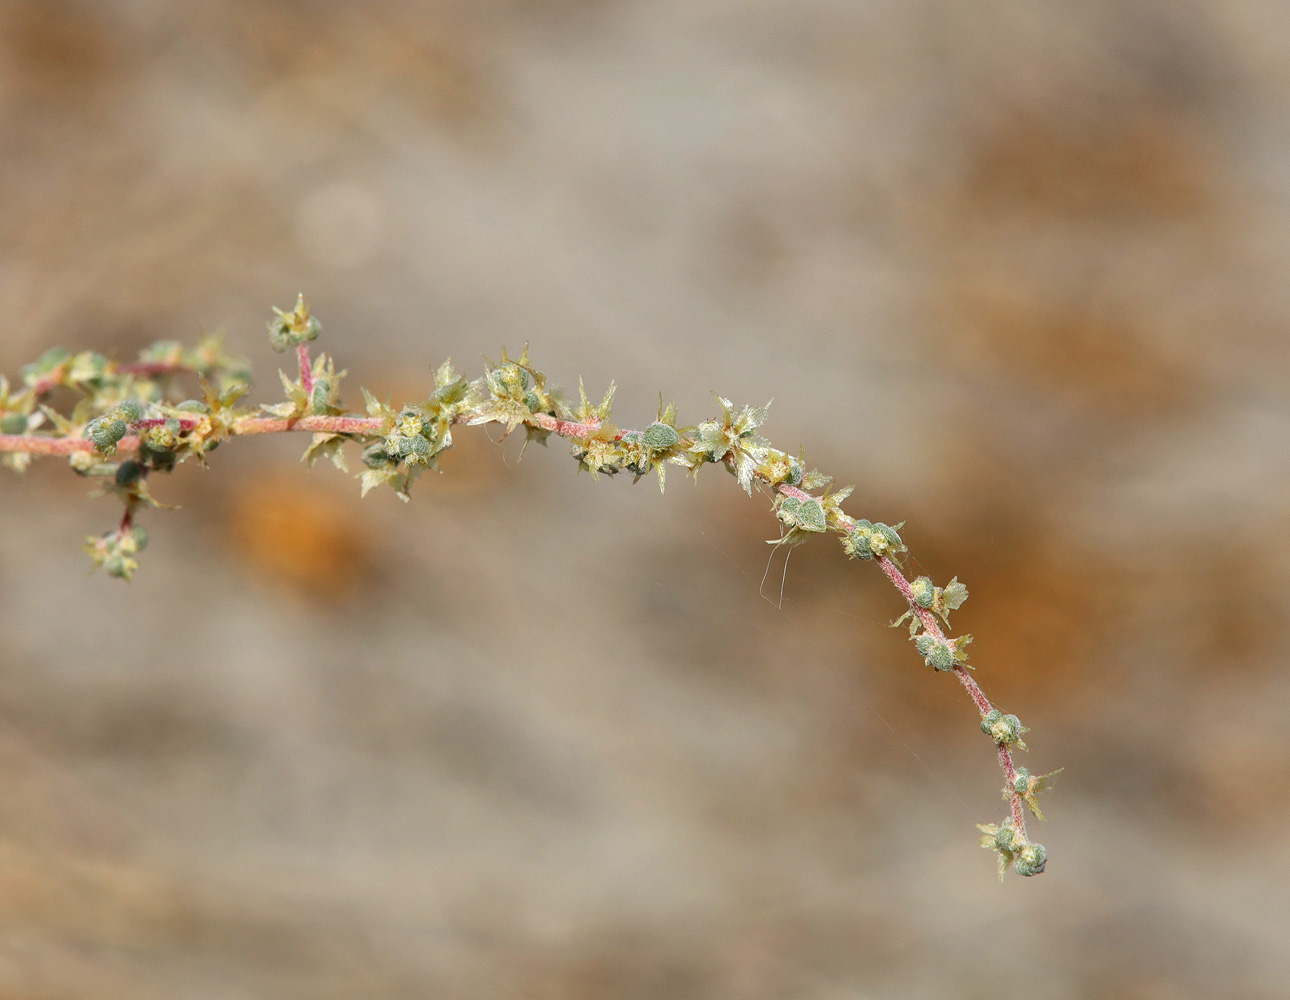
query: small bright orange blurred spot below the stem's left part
[{"left": 231, "top": 474, "right": 370, "bottom": 597}]
